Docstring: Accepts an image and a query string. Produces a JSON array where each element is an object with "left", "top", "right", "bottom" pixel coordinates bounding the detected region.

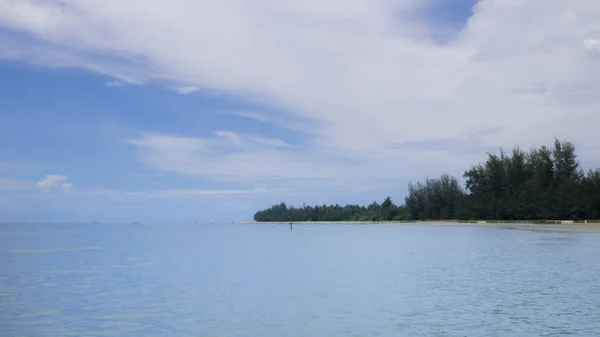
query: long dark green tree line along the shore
[{"left": 254, "top": 139, "right": 600, "bottom": 222}]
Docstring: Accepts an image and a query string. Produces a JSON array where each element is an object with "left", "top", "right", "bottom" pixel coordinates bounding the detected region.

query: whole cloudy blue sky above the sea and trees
[{"left": 0, "top": 0, "right": 600, "bottom": 223}]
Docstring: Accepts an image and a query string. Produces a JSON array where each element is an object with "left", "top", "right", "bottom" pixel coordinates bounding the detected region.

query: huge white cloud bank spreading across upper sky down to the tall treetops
[{"left": 0, "top": 0, "right": 600, "bottom": 190}]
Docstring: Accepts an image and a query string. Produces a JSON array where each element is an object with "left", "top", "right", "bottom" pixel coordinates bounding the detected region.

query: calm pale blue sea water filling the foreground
[{"left": 0, "top": 224, "right": 600, "bottom": 337}]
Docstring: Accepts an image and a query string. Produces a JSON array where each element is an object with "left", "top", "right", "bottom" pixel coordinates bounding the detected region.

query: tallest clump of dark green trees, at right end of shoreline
[{"left": 448, "top": 139, "right": 600, "bottom": 220}]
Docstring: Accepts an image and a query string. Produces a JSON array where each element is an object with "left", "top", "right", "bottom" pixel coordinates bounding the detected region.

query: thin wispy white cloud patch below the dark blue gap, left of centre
[{"left": 126, "top": 131, "right": 336, "bottom": 182}]
